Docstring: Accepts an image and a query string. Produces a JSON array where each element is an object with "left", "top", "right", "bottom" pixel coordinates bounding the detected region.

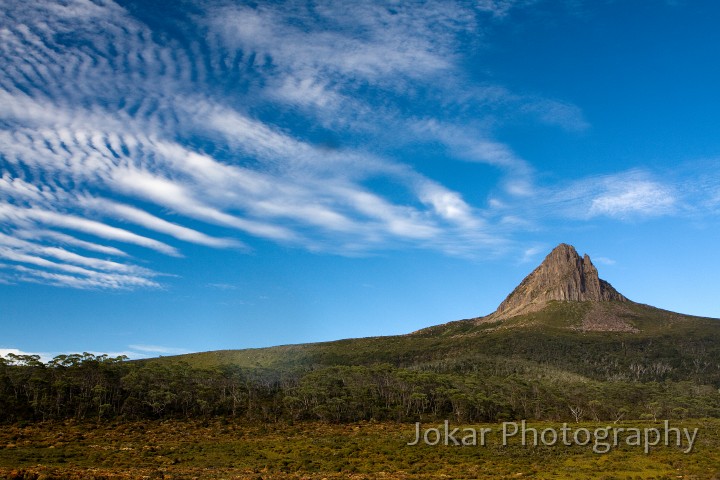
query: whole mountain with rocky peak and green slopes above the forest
[{"left": 153, "top": 244, "right": 720, "bottom": 385}]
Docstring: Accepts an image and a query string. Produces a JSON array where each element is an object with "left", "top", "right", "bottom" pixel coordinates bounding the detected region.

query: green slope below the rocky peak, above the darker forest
[{"left": 158, "top": 302, "right": 720, "bottom": 386}]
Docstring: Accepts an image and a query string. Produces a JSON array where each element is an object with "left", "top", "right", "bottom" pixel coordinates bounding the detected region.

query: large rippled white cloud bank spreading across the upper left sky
[{"left": 0, "top": 0, "right": 608, "bottom": 288}]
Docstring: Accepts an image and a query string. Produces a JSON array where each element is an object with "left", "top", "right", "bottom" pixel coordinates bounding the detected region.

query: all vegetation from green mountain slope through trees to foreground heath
[{"left": 0, "top": 302, "right": 720, "bottom": 479}]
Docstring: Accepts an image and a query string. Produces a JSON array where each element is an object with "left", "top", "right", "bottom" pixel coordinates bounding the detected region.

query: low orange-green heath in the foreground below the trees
[{"left": 0, "top": 419, "right": 720, "bottom": 480}]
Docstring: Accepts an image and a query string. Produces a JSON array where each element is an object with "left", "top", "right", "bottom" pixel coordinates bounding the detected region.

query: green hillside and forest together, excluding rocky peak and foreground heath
[{"left": 0, "top": 302, "right": 720, "bottom": 423}]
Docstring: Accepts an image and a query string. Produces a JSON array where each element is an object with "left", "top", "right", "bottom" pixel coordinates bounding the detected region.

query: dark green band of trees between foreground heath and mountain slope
[{"left": 0, "top": 353, "right": 720, "bottom": 423}]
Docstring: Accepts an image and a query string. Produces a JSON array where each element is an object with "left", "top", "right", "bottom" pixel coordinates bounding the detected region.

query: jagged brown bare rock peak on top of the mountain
[{"left": 491, "top": 243, "right": 628, "bottom": 319}]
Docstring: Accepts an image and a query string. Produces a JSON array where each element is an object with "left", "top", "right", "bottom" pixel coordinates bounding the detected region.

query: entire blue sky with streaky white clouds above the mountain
[{"left": 0, "top": 0, "right": 720, "bottom": 358}]
